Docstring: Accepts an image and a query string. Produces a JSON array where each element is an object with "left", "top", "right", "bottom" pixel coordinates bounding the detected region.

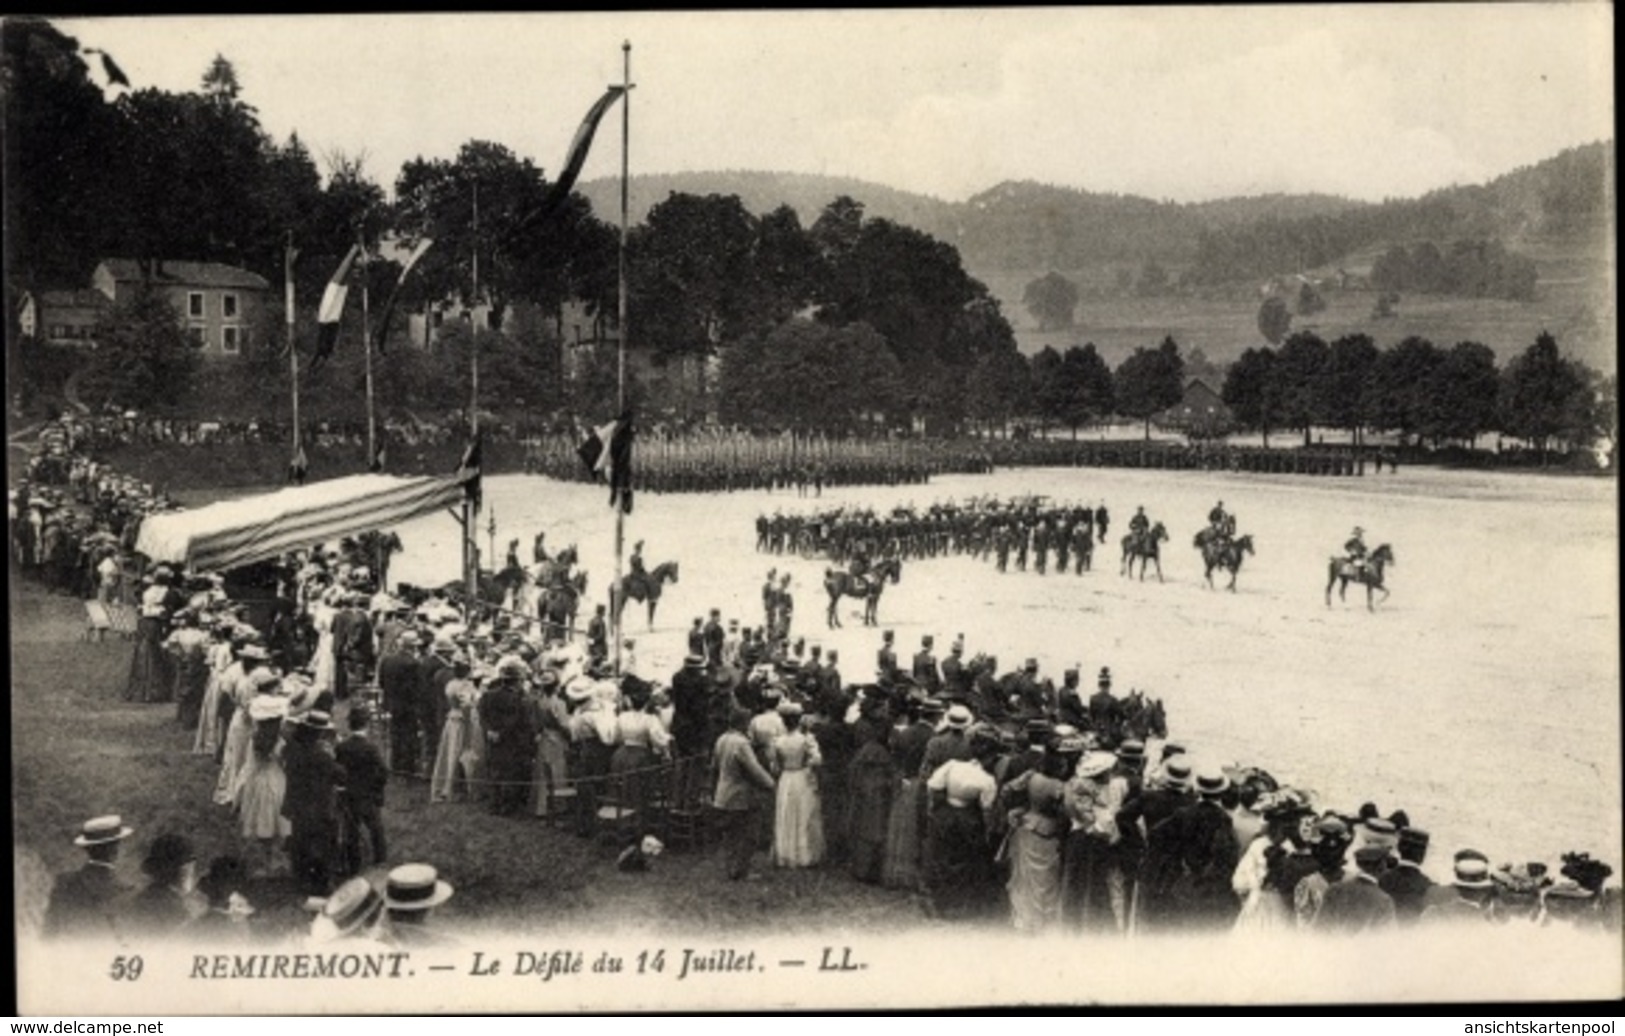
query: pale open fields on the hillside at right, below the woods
[{"left": 973, "top": 248, "right": 1615, "bottom": 370}]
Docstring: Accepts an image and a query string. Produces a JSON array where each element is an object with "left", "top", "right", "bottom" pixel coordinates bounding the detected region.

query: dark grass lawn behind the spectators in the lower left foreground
[{"left": 10, "top": 578, "right": 920, "bottom": 934}]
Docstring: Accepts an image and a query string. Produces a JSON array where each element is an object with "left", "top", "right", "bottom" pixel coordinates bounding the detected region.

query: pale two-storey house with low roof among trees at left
[{"left": 91, "top": 258, "right": 271, "bottom": 359}]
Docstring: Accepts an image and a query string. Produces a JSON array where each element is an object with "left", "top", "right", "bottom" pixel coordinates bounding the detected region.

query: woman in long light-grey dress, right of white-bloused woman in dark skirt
[{"left": 1004, "top": 739, "right": 1082, "bottom": 932}]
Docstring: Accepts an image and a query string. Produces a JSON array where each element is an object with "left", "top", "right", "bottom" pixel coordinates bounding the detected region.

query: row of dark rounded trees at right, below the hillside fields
[{"left": 1220, "top": 331, "right": 1617, "bottom": 451}]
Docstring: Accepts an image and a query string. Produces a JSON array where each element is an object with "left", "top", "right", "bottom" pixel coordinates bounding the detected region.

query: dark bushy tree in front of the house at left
[{"left": 81, "top": 287, "right": 202, "bottom": 411}]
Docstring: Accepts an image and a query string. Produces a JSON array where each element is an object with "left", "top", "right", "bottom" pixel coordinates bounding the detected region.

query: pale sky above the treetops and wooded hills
[{"left": 57, "top": 2, "right": 1614, "bottom": 201}]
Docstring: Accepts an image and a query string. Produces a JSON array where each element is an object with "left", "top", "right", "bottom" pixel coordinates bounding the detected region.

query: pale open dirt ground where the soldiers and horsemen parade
[{"left": 392, "top": 469, "right": 1622, "bottom": 870}]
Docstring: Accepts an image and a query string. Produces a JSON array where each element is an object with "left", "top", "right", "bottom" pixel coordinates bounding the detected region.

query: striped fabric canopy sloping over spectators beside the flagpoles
[{"left": 135, "top": 474, "right": 463, "bottom": 572}]
